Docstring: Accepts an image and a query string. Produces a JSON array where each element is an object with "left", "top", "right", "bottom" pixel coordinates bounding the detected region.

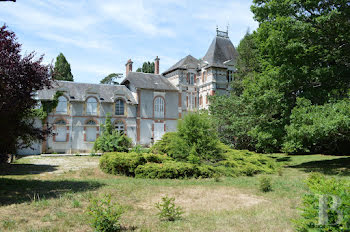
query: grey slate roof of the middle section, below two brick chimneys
[{"left": 121, "top": 72, "right": 177, "bottom": 91}]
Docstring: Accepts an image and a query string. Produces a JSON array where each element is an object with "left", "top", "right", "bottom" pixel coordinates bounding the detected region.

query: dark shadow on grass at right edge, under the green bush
[{"left": 288, "top": 157, "right": 350, "bottom": 176}]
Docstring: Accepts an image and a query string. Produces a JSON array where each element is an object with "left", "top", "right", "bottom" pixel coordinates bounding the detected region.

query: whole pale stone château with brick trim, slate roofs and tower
[{"left": 18, "top": 30, "right": 237, "bottom": 154}]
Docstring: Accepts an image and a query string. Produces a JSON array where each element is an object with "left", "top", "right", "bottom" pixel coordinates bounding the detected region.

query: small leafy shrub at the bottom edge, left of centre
[{"left": 88, "top": 195, "right": 123, "bottom": 232}]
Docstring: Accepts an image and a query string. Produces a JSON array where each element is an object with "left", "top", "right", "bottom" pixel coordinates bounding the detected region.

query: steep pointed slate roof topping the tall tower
[{"left": 203, "top": 36, "right": 238, "bottom": 67}]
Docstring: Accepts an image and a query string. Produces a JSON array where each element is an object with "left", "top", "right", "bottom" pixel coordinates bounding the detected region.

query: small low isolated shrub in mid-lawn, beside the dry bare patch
[{"left": 156, "top": 196, "right": 183, "bottom": 221}]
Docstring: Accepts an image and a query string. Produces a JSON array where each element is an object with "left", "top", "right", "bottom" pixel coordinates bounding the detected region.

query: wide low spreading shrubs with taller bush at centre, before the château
[{"left": 100, "top": 113, "right": 277, "bottom": 179}]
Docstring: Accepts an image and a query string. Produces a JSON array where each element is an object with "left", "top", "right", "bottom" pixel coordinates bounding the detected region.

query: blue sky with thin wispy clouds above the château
[{"left": 0, "top": 0, "right": 258, "bottom": 83}]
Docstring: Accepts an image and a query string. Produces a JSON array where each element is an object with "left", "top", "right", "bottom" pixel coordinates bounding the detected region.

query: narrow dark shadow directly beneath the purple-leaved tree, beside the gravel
[{"left": 0, "top": 164, "right": 57, "bottom": 176}]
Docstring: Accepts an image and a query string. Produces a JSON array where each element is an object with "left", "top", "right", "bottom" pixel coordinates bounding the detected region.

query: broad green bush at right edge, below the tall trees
[{"left": 283, "top": 99, "right": 350, "bottom": 154}]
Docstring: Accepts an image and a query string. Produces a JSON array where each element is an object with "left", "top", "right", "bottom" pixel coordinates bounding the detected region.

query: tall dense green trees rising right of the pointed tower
[{"left": 211, "top": 0, "right": 350, "bottom": 152}]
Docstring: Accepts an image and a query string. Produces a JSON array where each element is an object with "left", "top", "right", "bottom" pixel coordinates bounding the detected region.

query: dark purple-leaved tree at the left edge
[{"left": 0, "top": 26, "right": 51, "bottom": 161}]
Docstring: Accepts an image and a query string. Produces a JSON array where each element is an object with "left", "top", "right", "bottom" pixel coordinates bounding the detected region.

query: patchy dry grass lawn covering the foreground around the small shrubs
[{"left": 0, "top": 154, "right": 350, "bottom": 231}]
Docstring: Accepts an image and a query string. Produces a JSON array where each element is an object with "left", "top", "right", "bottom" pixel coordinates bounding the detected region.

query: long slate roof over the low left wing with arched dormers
[{"left": 37, "top": 81, "right": 137, "bottom": 104}]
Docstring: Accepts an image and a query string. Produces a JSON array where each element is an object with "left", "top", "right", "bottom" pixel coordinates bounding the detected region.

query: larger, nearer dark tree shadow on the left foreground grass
[{"left": 0, "top": 178, "right": 103, "bottom": 206}]
